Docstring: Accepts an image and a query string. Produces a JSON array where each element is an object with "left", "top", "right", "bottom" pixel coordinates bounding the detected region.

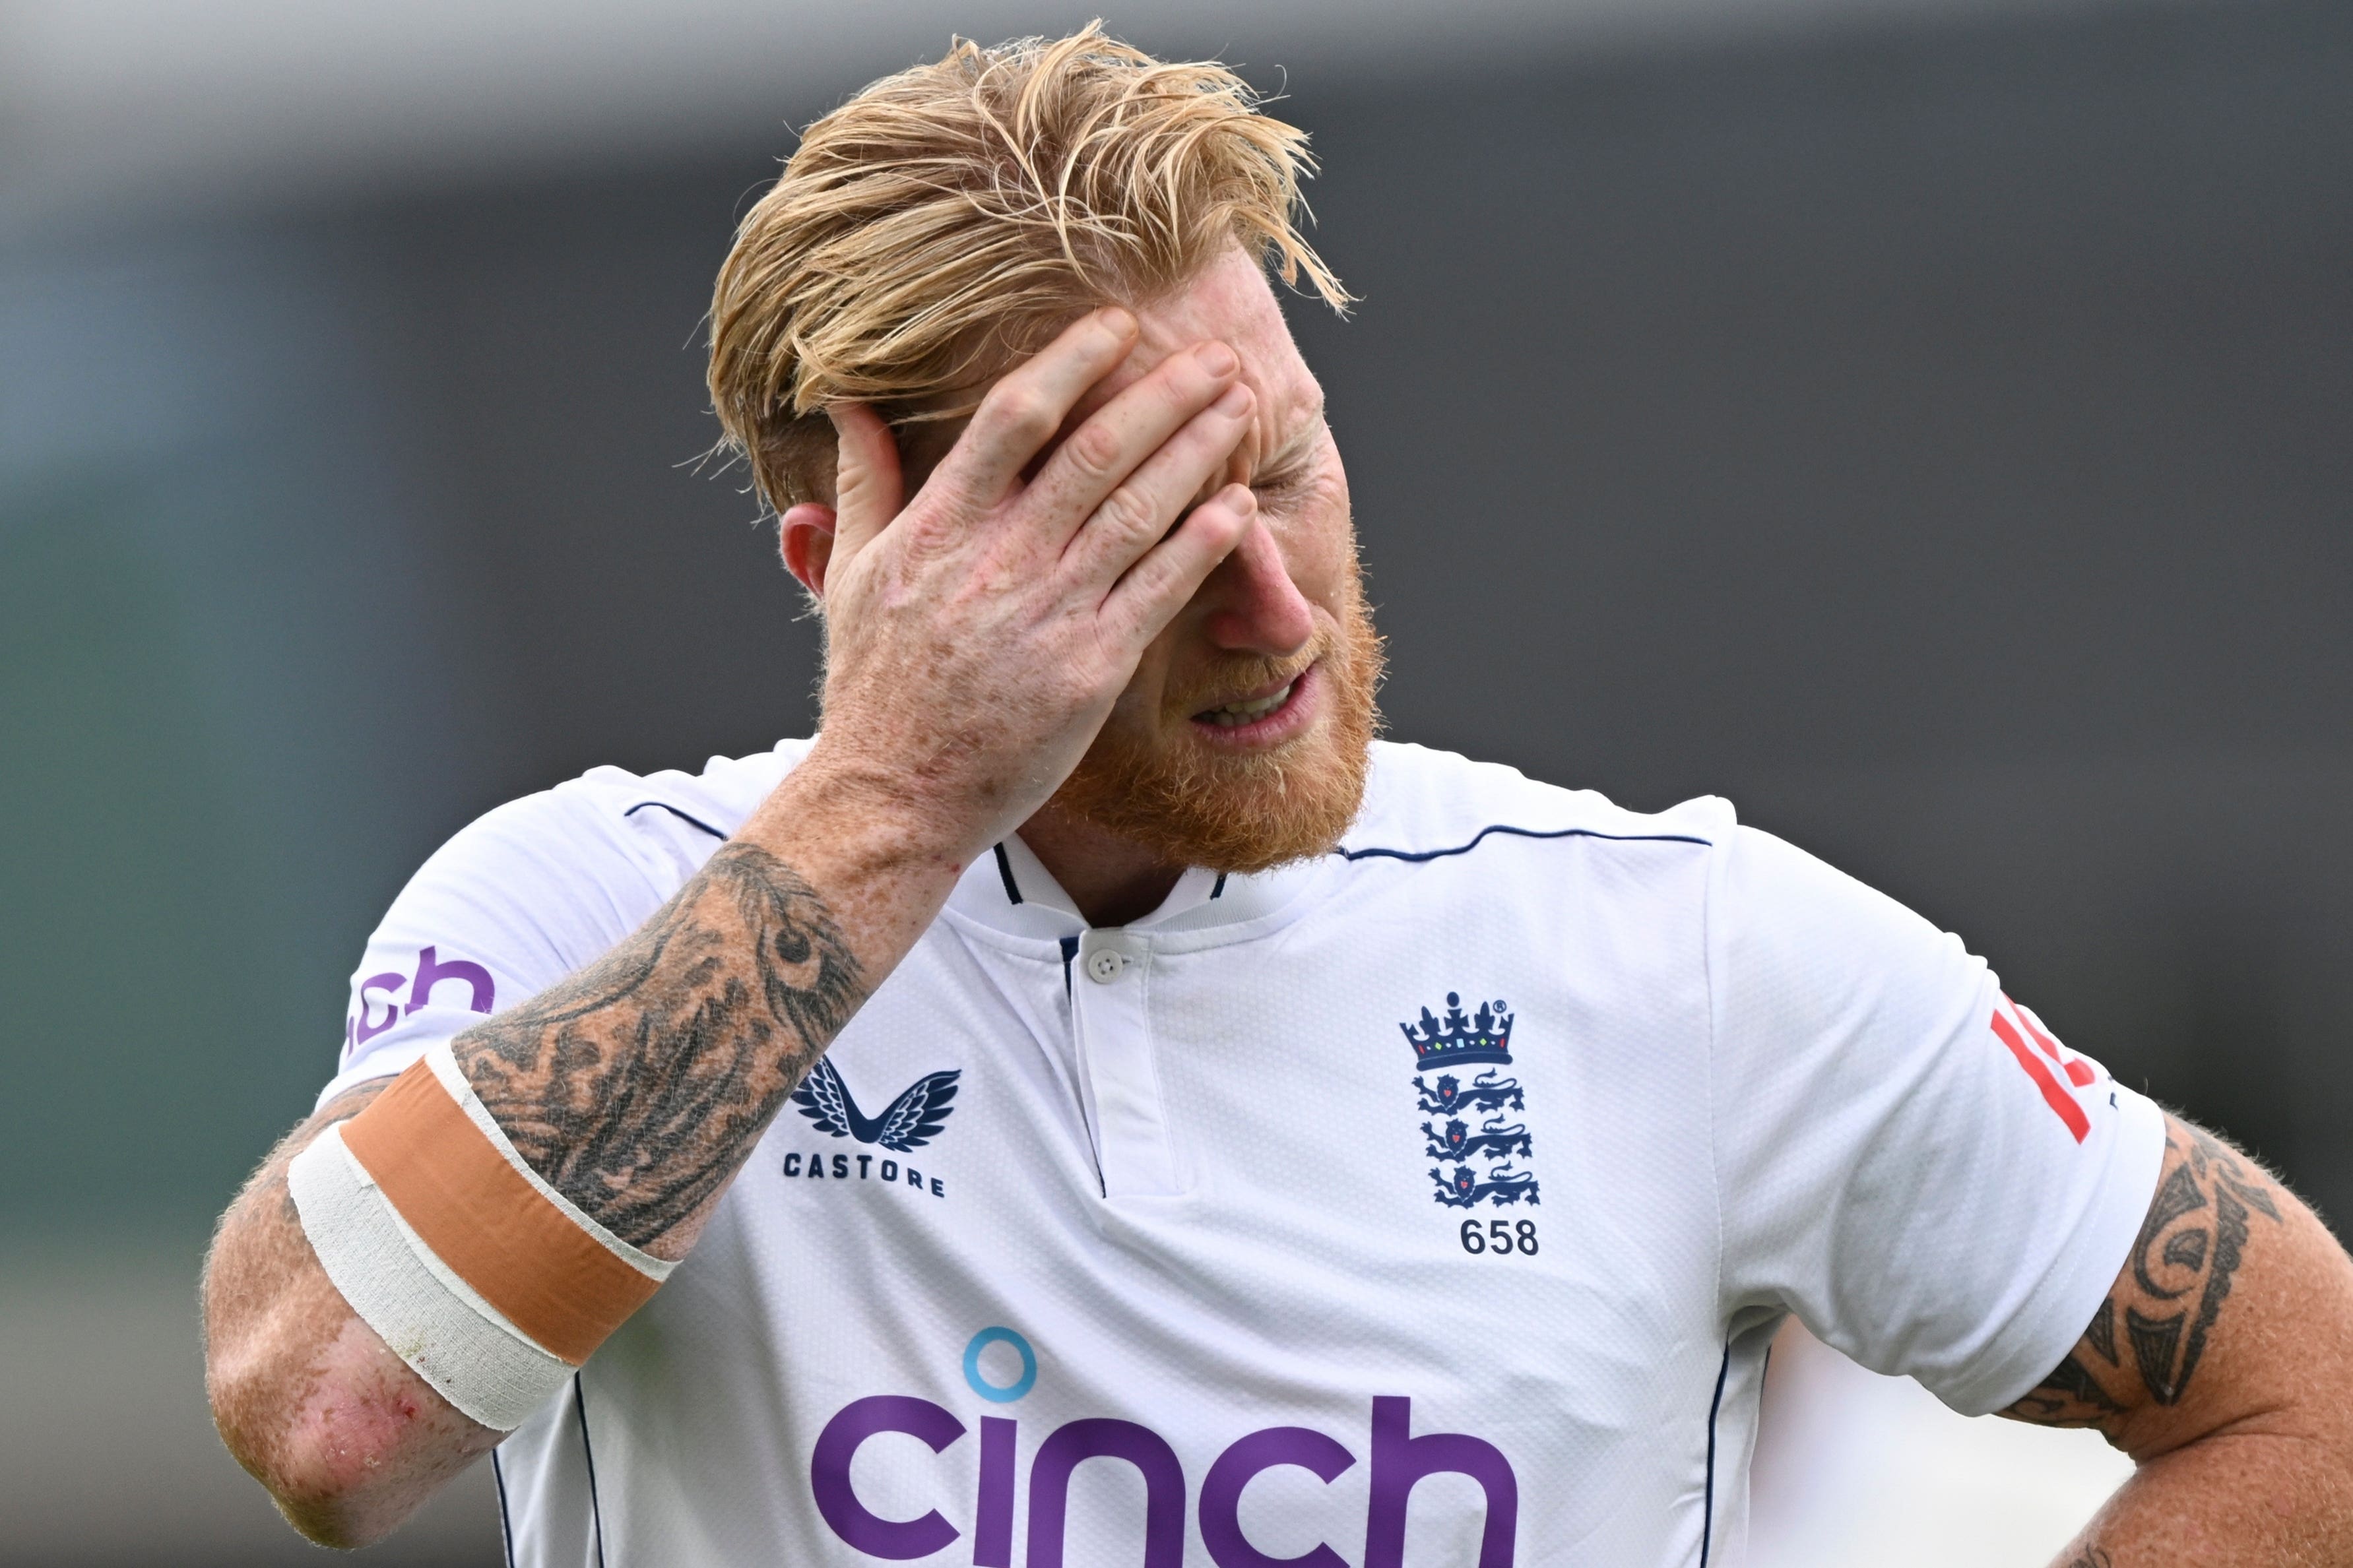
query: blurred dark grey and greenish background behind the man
[{"left": 0, "top": 0, "right": 2353, "bottom": 1563}]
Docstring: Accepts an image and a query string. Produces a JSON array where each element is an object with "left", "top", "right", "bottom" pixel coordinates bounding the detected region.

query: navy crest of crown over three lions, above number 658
[{"left": 1398, "top": 992, "right": 1537, "bottom": 1225}]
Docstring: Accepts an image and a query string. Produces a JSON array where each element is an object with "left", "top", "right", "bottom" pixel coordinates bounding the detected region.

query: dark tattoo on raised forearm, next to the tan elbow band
[{"left": 454, "top": 842, "right": 868, "bottom": 1246}]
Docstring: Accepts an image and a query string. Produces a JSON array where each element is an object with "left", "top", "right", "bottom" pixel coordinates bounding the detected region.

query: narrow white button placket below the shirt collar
[{"left": 1071, "top": 931, "right": 1179, "bottom": 1199}]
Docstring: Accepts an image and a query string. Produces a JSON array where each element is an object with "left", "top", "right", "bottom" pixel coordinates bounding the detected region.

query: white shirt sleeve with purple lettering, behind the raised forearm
[{"left": 317, "top": 788, "right": 685, "bottom": 1105}]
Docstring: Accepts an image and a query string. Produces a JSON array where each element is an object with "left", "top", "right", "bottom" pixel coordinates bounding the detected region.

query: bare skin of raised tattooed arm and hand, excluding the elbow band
[{"left": 205, "top": 270, "right": 1301, "bottom": 1547}]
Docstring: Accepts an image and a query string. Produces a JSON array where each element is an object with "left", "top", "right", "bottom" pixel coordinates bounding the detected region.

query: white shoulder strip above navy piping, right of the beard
[{"left": 1341, "top": 741, "right": 1739, "bottom": 863}]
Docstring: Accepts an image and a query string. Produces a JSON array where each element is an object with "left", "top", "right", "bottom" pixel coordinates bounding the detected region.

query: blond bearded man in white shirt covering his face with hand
[{"left": 205, "top": 30, "right": 2353, "bottom": 1568}]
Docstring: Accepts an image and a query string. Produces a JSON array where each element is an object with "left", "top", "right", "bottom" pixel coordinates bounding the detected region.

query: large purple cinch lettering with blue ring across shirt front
[{"left": 810, "top": 1329, "right": 1520, "bottom": 1568}]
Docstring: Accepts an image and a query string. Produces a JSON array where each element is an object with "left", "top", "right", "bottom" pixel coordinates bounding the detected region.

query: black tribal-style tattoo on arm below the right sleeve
[{"left": 2003, "top": 1121, "right": 2280, "bottom": 1427}]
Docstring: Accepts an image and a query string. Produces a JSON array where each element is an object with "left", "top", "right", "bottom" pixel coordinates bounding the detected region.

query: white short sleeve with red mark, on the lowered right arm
[{"left": 1708, "top": 827, "right": 2165, "bottom": 1415}]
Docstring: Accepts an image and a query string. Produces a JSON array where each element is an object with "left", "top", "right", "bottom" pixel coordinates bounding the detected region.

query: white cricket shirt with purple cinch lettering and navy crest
[{"left": 327, "top": 741, "right": 2165, "bottom": 1568}]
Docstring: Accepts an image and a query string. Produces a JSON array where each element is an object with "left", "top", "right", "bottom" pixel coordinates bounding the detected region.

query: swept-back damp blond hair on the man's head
[{"left": 711, "top": 24, "right": 1348, "bottom": 510}]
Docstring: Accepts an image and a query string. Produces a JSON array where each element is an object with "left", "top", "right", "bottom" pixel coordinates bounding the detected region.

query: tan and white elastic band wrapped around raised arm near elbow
[{"left": 287, "top": 1044, "right": 675, "bottom": 1431}]
